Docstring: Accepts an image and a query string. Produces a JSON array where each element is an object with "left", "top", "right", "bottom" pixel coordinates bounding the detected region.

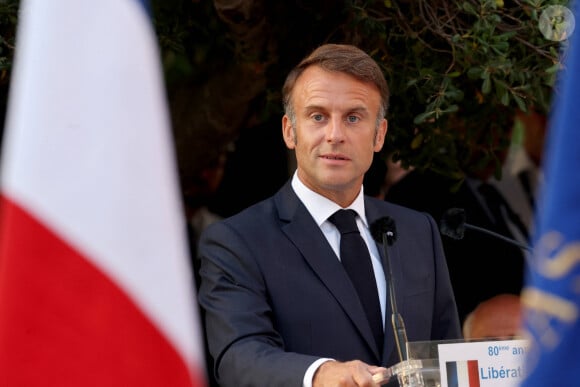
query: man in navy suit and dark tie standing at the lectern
[{"left": 199, "top": 44, "right": 461, "bottom": 387}]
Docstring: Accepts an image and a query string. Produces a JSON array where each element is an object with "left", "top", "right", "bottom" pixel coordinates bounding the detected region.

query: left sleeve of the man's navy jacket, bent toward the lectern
[{"left": 198, "top": 222, "right": 317, "bottom": 386}]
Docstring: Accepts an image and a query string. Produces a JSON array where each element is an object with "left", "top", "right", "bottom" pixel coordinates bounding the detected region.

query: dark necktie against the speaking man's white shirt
[{"left": 328, "top": 210, "right": 384, "bottom": 351}]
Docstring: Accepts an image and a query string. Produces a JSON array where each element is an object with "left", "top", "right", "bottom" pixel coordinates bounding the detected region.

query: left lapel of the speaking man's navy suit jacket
[{"left": 276, "top": 184, "right": 380, "bottom": 359}]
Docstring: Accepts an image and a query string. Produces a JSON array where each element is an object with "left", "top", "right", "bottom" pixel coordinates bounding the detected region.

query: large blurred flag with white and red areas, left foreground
[{"left": 0, "top": 0, "right": 207, "bottom": 387}]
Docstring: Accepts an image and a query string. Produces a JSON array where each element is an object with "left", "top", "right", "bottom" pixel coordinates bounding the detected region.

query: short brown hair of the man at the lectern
[{"left": 282, "top": 44, "right": 389, "bottom": 118}]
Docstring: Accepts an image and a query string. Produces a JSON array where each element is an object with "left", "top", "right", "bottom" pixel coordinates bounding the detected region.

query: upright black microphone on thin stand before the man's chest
[{"left": 370, "top": 216, "right": 408, "bottom": 361}]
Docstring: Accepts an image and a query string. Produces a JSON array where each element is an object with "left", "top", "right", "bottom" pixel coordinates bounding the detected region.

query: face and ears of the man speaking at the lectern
[{"left": 282, "top": 66, "right": 387, "bottom": 206}]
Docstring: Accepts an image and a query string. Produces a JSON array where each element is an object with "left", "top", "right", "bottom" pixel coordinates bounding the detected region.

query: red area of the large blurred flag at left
[{"left": 0, "top": 197, "right": 202, "bottom": 387}]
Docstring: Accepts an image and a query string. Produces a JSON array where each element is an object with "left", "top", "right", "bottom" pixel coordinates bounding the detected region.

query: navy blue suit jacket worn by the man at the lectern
[{"left": 199, "top": 181, "right": 461, "bottom": 386}]
